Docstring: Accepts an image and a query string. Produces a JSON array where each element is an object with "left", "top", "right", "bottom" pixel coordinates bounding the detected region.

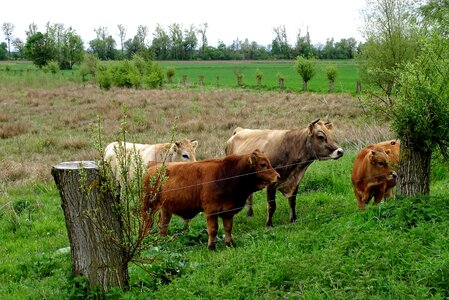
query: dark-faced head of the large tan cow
[{"left": 307, "top": 119, "right": 344, "bottom": 160}]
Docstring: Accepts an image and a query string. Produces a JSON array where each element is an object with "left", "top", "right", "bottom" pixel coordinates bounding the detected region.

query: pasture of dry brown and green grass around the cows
[{"left": 0, "top": 72, "right": 449, "bottom": 299}]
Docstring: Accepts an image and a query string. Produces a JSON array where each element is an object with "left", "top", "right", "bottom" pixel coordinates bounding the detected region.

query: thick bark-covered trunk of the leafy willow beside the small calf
[{"left": 397, "top": 139, "right": 432, "bottom": 196}]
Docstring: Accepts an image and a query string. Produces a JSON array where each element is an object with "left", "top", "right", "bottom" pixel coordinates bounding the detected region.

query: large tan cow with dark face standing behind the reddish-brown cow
[{"left": 226, "top": 119, "right": 343, "bottom": 226}]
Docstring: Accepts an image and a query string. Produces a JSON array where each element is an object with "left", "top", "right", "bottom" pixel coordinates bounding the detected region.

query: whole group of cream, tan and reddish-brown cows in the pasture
[{"left": 104, "top": 119, "right": 399, "bottom": 249}]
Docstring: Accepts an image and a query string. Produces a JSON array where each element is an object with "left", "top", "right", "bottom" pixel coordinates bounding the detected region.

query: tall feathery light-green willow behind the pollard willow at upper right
[{"left": 358, "top": 0, "right": 417, "bottom": 96}]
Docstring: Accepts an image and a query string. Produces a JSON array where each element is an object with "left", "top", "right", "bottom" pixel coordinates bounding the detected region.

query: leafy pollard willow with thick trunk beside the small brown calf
[{"left": 392, "top": 31, "right": 449, "bottom": 196}]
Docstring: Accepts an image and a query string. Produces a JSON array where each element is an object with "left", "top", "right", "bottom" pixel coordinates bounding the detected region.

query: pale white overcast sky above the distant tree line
[{"left": 0, "top": 0, "right": 366, "bottom": 46}]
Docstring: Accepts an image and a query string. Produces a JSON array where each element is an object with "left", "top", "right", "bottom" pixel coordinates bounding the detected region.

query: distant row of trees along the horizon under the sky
[{"left": 0, "top": 23, "right": 360, "bottom": 69}]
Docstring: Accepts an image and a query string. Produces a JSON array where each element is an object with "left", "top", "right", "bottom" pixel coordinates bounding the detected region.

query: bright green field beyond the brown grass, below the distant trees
[{"left": 0, "top": 60, "right": 359, "bottom": 94}]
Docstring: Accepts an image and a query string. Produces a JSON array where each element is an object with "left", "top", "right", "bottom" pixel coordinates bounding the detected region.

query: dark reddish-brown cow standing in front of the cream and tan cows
[{"left": 143, "top": 150, "right": 279, "bottom": 250}]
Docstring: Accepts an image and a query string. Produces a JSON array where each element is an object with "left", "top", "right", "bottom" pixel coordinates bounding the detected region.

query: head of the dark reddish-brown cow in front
[{"left": 248, "top": 149, "right": 280, "bottom": 190}]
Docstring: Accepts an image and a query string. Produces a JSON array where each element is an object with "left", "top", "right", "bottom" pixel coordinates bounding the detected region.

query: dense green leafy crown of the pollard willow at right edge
[{"left": 393, "top": 33, "right": 449, "bottom": 149}]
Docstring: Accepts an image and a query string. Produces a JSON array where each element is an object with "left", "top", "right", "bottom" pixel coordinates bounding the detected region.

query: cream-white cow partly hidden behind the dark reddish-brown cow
[{"left": 104, "top": 139, "right": 198, "bottom": 178}]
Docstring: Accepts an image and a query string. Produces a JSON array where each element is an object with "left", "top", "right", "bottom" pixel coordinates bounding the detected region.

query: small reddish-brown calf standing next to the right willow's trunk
[{"left": 351, "top": 145, "right": 397, "bottom": 210}]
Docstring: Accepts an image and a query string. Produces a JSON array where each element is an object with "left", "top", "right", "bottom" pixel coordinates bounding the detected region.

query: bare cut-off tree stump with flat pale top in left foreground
[{"left": 51, "top": 161, "right": 129, "bottom": 291}]
